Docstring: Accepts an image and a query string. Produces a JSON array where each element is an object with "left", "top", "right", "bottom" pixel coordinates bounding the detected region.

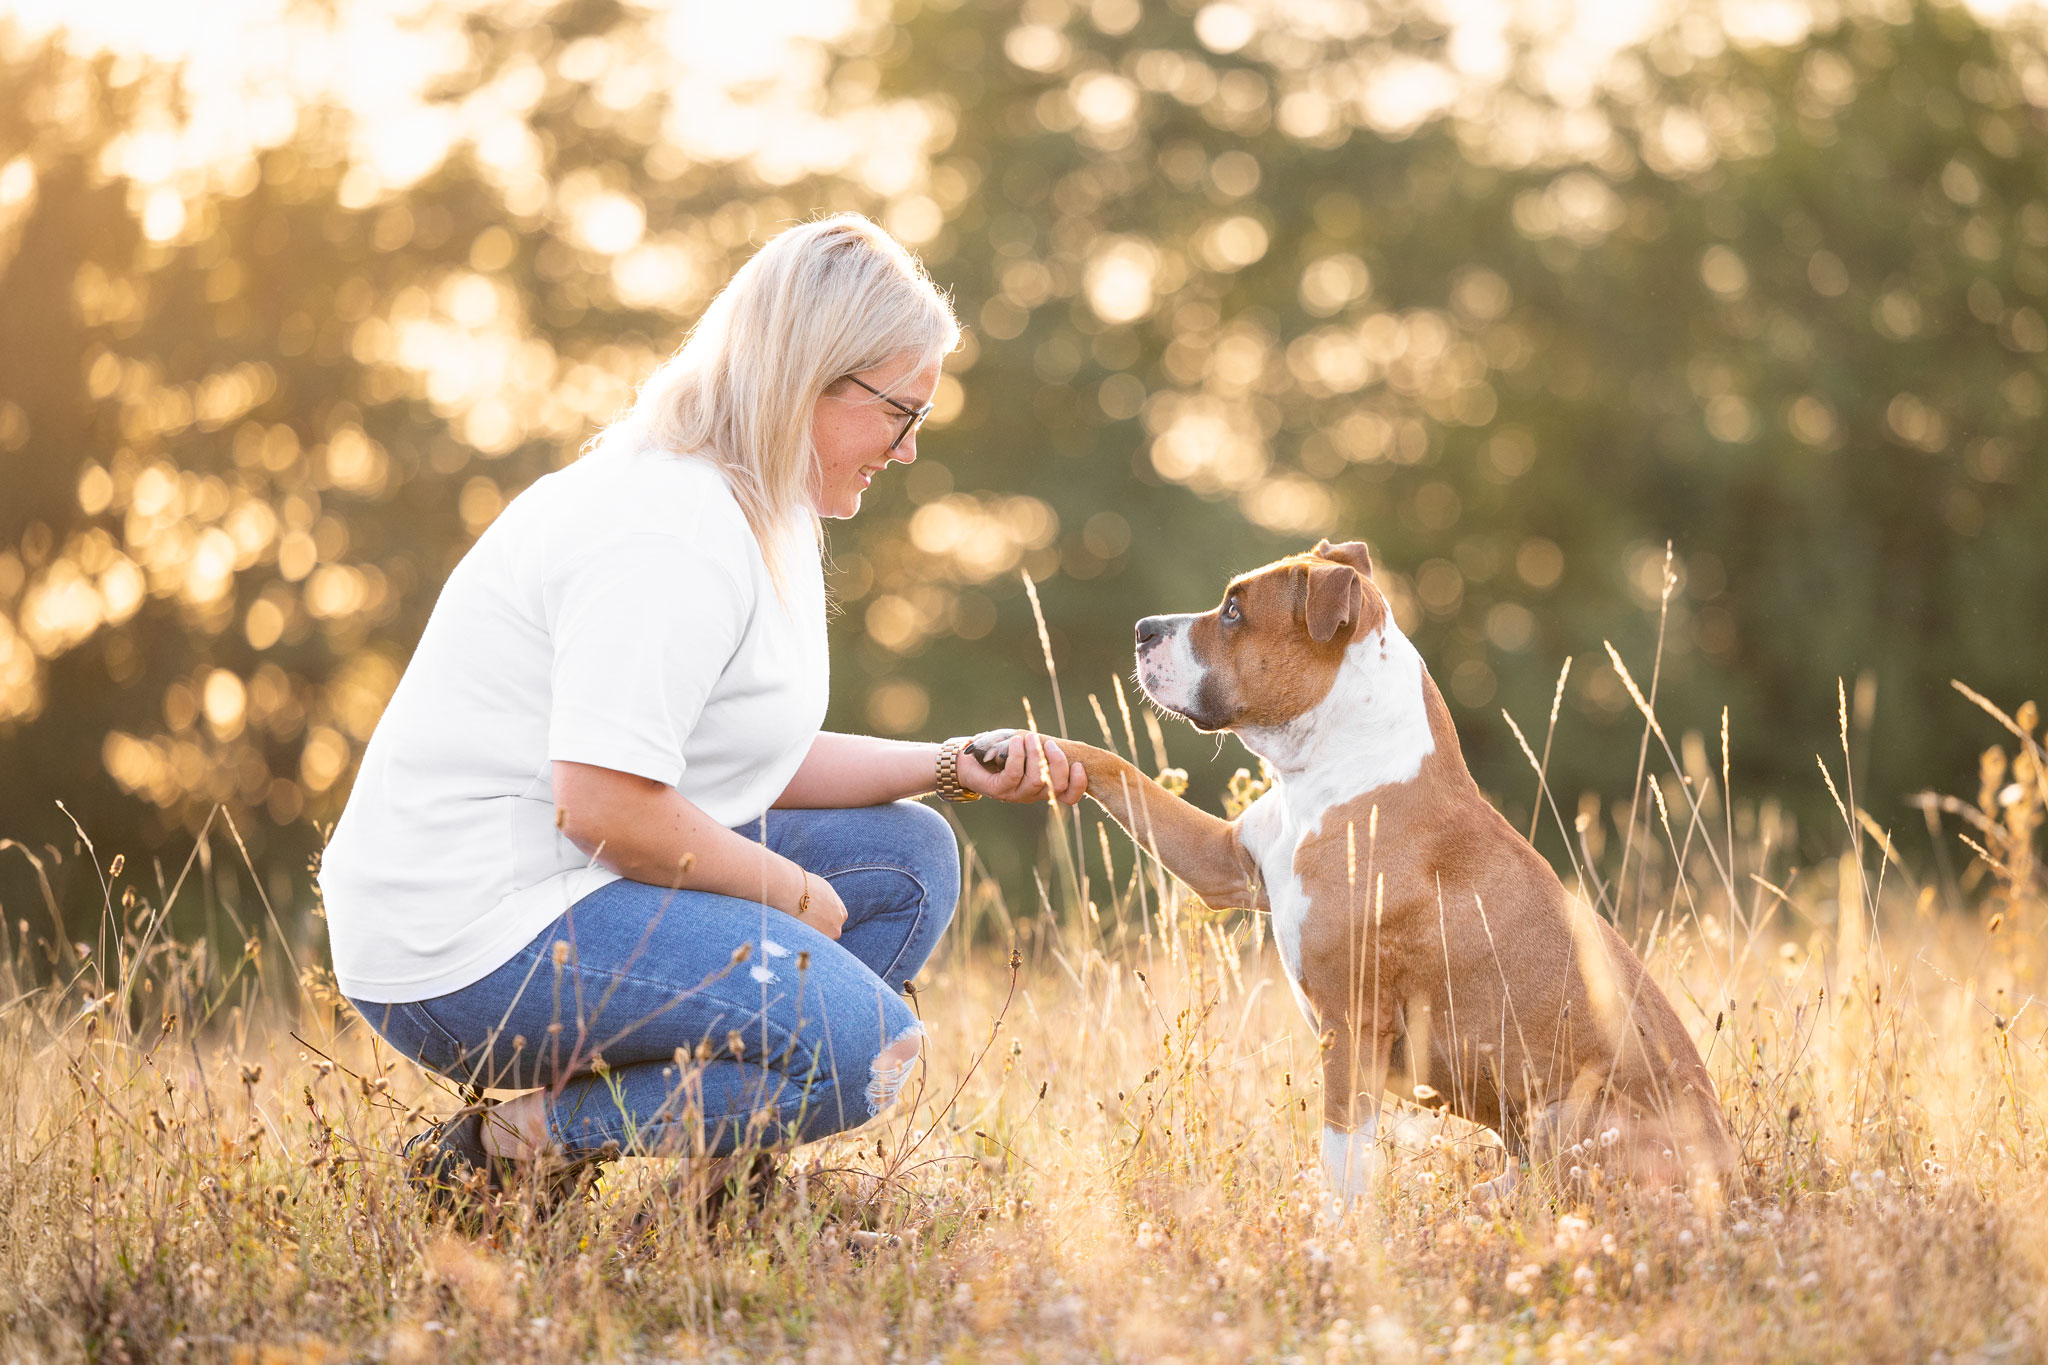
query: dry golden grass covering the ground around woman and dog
[{"left": 0, "top": 679, "right": 2048, "bottom": 1363}]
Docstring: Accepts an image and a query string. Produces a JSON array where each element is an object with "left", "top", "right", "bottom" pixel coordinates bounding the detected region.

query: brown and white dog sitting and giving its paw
[{"left": 973, "top": 540, "right": 1741, "bottom": 1209}]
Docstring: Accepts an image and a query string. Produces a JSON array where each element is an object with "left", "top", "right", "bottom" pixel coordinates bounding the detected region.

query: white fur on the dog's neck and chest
[{"left": 1239, "top": 622, "right": 1436, "bottom": 1023}]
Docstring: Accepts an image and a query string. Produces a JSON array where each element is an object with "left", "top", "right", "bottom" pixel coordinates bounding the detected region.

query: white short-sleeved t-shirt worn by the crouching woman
[{"left": 319, "top": 440, "right": 827, "bottom": 1003}]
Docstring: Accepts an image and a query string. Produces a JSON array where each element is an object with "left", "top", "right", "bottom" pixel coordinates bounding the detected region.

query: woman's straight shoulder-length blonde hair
[{"left": 604, "top": 213, "right": 961, "bottom": 585}]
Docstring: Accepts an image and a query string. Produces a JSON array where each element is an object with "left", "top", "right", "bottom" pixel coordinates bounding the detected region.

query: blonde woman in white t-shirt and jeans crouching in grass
[{"left": 319, "top": 215, "right": 1085, "bottom": 1201}]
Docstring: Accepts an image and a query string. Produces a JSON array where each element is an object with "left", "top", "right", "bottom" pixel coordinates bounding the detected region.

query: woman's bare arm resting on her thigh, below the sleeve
[{"left": 553, "top": 759, "right": 846, "bottom": 939}]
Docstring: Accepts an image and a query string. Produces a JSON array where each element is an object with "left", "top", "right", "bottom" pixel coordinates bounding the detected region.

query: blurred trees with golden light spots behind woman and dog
[{"left": 0, "top": 0, "right": 2048, "bottom": 929}]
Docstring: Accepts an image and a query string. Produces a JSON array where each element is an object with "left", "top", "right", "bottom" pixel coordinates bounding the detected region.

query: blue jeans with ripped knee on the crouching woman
[{"left": 352, "top": 800, "right": 961, "bottom": 1156}]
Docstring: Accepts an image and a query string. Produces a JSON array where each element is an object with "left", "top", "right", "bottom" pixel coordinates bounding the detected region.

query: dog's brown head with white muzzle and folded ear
[{"left": 1139, "top": 540, "right": 1389, "bottom": 731}]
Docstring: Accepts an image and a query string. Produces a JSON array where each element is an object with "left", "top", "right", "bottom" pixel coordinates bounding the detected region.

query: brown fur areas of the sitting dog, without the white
[{"left": 977, "top": 542, "right": 1741, "bottom": 1185}]
